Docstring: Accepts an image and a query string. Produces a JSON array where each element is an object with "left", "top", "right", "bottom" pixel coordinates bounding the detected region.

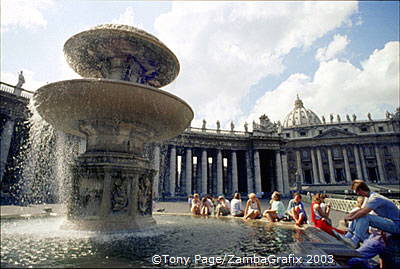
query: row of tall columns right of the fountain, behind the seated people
[{"left": 153, "top": 145, "right": 289, "bottom": 197}]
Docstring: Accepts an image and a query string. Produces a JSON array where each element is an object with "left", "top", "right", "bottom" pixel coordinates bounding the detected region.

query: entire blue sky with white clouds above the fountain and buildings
[{"left": 0, "top": 0, "right": 400, "bottom": 130}]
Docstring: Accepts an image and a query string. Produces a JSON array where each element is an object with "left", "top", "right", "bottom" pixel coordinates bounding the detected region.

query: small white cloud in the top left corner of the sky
[{"left": 1, "top": 0, "right": 53, "bottom": 31}]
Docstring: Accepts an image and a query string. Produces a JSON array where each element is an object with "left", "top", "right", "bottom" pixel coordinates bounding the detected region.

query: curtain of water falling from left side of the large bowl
[{"left": 13, "top": 101, "right": 81, "bottom": 205}]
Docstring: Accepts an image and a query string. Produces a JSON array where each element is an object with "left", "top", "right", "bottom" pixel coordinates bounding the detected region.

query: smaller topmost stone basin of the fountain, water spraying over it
[{"left": 64, "top": 24, "right": 179, "bottom": 88}]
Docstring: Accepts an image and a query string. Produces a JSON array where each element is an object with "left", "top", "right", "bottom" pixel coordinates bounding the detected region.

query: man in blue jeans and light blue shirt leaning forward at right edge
[{"left": 345, "top": 179, "right": 400, "bottom": 247}]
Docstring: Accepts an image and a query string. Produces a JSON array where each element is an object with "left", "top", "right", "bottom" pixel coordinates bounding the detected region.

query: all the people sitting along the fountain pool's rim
[{"left": 189, "top": 180, "right": 400, "bottom": 268}]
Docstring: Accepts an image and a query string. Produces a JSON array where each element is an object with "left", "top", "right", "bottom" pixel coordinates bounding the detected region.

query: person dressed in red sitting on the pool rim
[{"left": 311, "top": 193, "right": 346, "bottom": 237}]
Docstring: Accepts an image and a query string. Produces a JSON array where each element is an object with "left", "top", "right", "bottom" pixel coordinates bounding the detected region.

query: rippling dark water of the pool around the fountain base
[{"left": 1, "top": 215, "right": 302, "bottom": 268}]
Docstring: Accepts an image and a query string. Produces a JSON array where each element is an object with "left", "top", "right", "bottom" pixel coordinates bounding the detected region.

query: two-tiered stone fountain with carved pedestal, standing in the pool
[{"left": 34, "top": 24, "right": 193, "bottom": 231}]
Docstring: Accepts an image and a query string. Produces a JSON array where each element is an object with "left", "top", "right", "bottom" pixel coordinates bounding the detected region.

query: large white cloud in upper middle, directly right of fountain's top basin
[{"left": 155, "top": 1, "right": 357, "bottom": 128}]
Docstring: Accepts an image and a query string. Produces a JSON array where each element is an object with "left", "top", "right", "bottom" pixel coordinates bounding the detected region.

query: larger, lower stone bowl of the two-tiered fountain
[{"left": 34, "top": 79, "right": 193, "bottom": 142}]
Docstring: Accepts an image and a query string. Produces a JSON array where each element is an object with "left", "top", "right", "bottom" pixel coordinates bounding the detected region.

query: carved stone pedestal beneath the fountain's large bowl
[{"left": 63, "top": 153, "right": 155, "bottom": 231}]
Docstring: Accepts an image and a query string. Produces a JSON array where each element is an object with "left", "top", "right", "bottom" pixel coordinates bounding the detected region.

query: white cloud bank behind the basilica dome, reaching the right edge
[{"left": 247, "top": 41, "right": 400, "bottom": 121}]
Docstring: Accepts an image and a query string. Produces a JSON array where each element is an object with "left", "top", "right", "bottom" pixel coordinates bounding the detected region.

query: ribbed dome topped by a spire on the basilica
[{"left": 283, "top": 95, "right": 321, "bottom": 128}]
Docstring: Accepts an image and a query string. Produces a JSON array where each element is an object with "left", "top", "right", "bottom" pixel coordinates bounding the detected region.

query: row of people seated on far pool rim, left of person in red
[{"left": 188, "top": 191, "right": 307, "bottom": 226}]
